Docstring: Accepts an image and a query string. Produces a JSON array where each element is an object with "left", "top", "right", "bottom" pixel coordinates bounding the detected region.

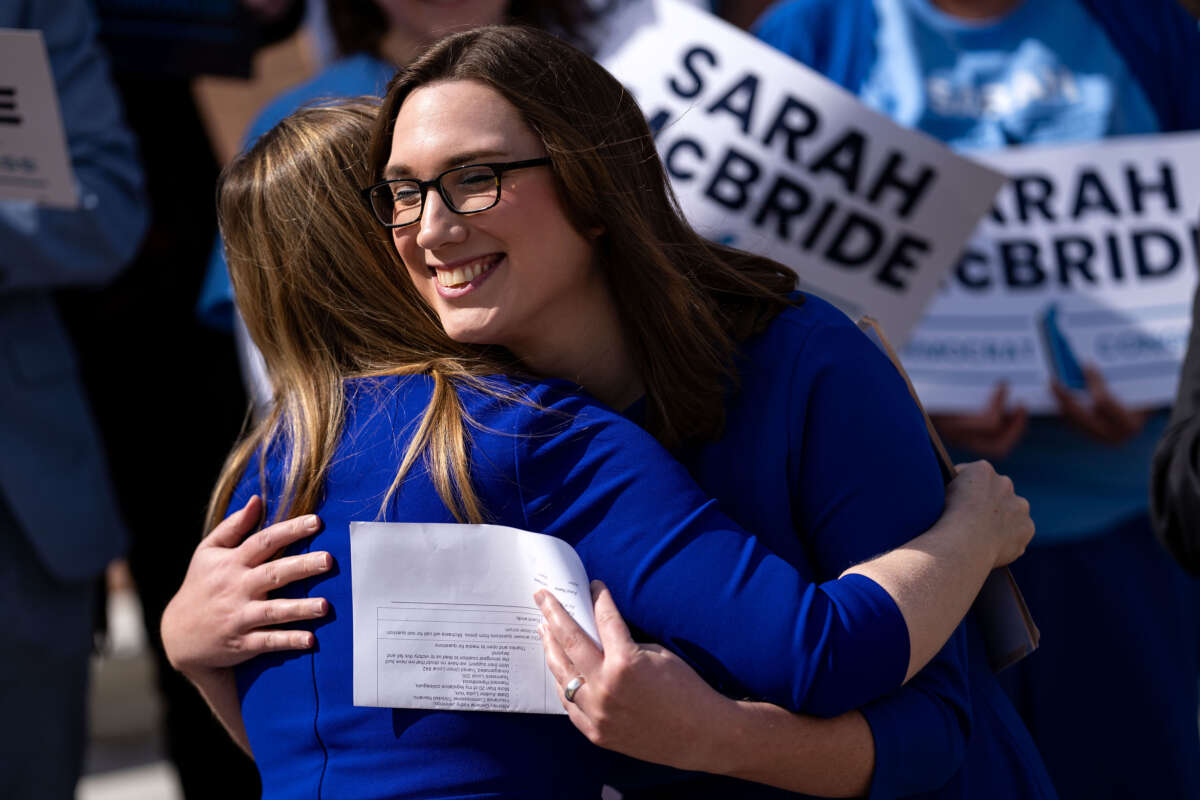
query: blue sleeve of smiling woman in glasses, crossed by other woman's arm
[{"left": 790, "top": 316, "right": 971, "bottom": 798}]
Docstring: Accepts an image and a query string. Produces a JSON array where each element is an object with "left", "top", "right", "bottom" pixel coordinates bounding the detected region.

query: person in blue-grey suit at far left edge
[{"left": 0, "top": 0, "right": 146, "bottom": 800}]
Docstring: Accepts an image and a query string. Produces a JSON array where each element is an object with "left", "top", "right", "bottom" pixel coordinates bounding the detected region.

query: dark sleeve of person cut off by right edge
[{"left": 1150, "top": 289, "right": 1200, "bottom": 576}]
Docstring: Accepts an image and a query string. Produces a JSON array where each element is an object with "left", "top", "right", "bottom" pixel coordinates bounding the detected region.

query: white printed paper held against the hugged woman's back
[{"left": 350, "top": 522, "right": 599, "bottom": 714}]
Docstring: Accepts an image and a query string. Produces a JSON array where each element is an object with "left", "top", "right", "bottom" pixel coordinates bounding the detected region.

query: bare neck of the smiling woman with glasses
[{"left": 509, "top": 273, "right": 646, "bottom": 410}]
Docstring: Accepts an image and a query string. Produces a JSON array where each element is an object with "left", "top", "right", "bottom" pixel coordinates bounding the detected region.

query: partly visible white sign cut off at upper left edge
[{"left": 0, "top": 29, "right": 79, "bottom": 209}]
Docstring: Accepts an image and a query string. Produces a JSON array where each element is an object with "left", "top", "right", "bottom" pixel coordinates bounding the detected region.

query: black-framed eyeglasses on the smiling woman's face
[{"left": 361, "top": 156, "right": 550, "bottom": 228}]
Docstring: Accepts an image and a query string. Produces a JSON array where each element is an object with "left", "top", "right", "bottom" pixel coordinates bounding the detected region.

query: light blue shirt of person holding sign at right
[{"left": 757, "top": 0, "right": 1177, "bottom": 543}]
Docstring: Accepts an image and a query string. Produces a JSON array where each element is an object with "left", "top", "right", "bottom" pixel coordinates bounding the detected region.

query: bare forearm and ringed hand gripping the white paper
[{"left": 535, "top": 581, "right": 875, "bottom": 798}]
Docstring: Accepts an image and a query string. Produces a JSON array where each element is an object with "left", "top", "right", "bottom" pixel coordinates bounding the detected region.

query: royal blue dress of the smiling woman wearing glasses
[{"left": 617, "top": 297, "right": 1055, "bottom": 800}]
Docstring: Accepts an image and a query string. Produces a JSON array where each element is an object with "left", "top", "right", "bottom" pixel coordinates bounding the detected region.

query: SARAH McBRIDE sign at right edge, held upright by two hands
[{"left": 901, "top": 133, "right": 1200, "bottom": 411}]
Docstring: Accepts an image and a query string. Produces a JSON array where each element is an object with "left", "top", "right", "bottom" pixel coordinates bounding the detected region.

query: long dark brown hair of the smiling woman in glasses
[{"left": 371, "top": 25, "right": 796, "bottom": 447}]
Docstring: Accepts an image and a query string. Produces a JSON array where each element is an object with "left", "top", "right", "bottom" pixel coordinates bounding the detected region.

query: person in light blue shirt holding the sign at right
[{"left": 757, "top": 0, "right": 1200, "bottom": 800}]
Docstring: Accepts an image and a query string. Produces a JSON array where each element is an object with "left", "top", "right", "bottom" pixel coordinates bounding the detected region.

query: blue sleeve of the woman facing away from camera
[{"left": 514, "top": 383, "right": 908, "bottom": 714}]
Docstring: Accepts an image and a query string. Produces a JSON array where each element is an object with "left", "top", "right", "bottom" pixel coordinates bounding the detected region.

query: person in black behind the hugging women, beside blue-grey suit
[{"left": 58, "top": 0, "right": 305, "bottom": 800}]
